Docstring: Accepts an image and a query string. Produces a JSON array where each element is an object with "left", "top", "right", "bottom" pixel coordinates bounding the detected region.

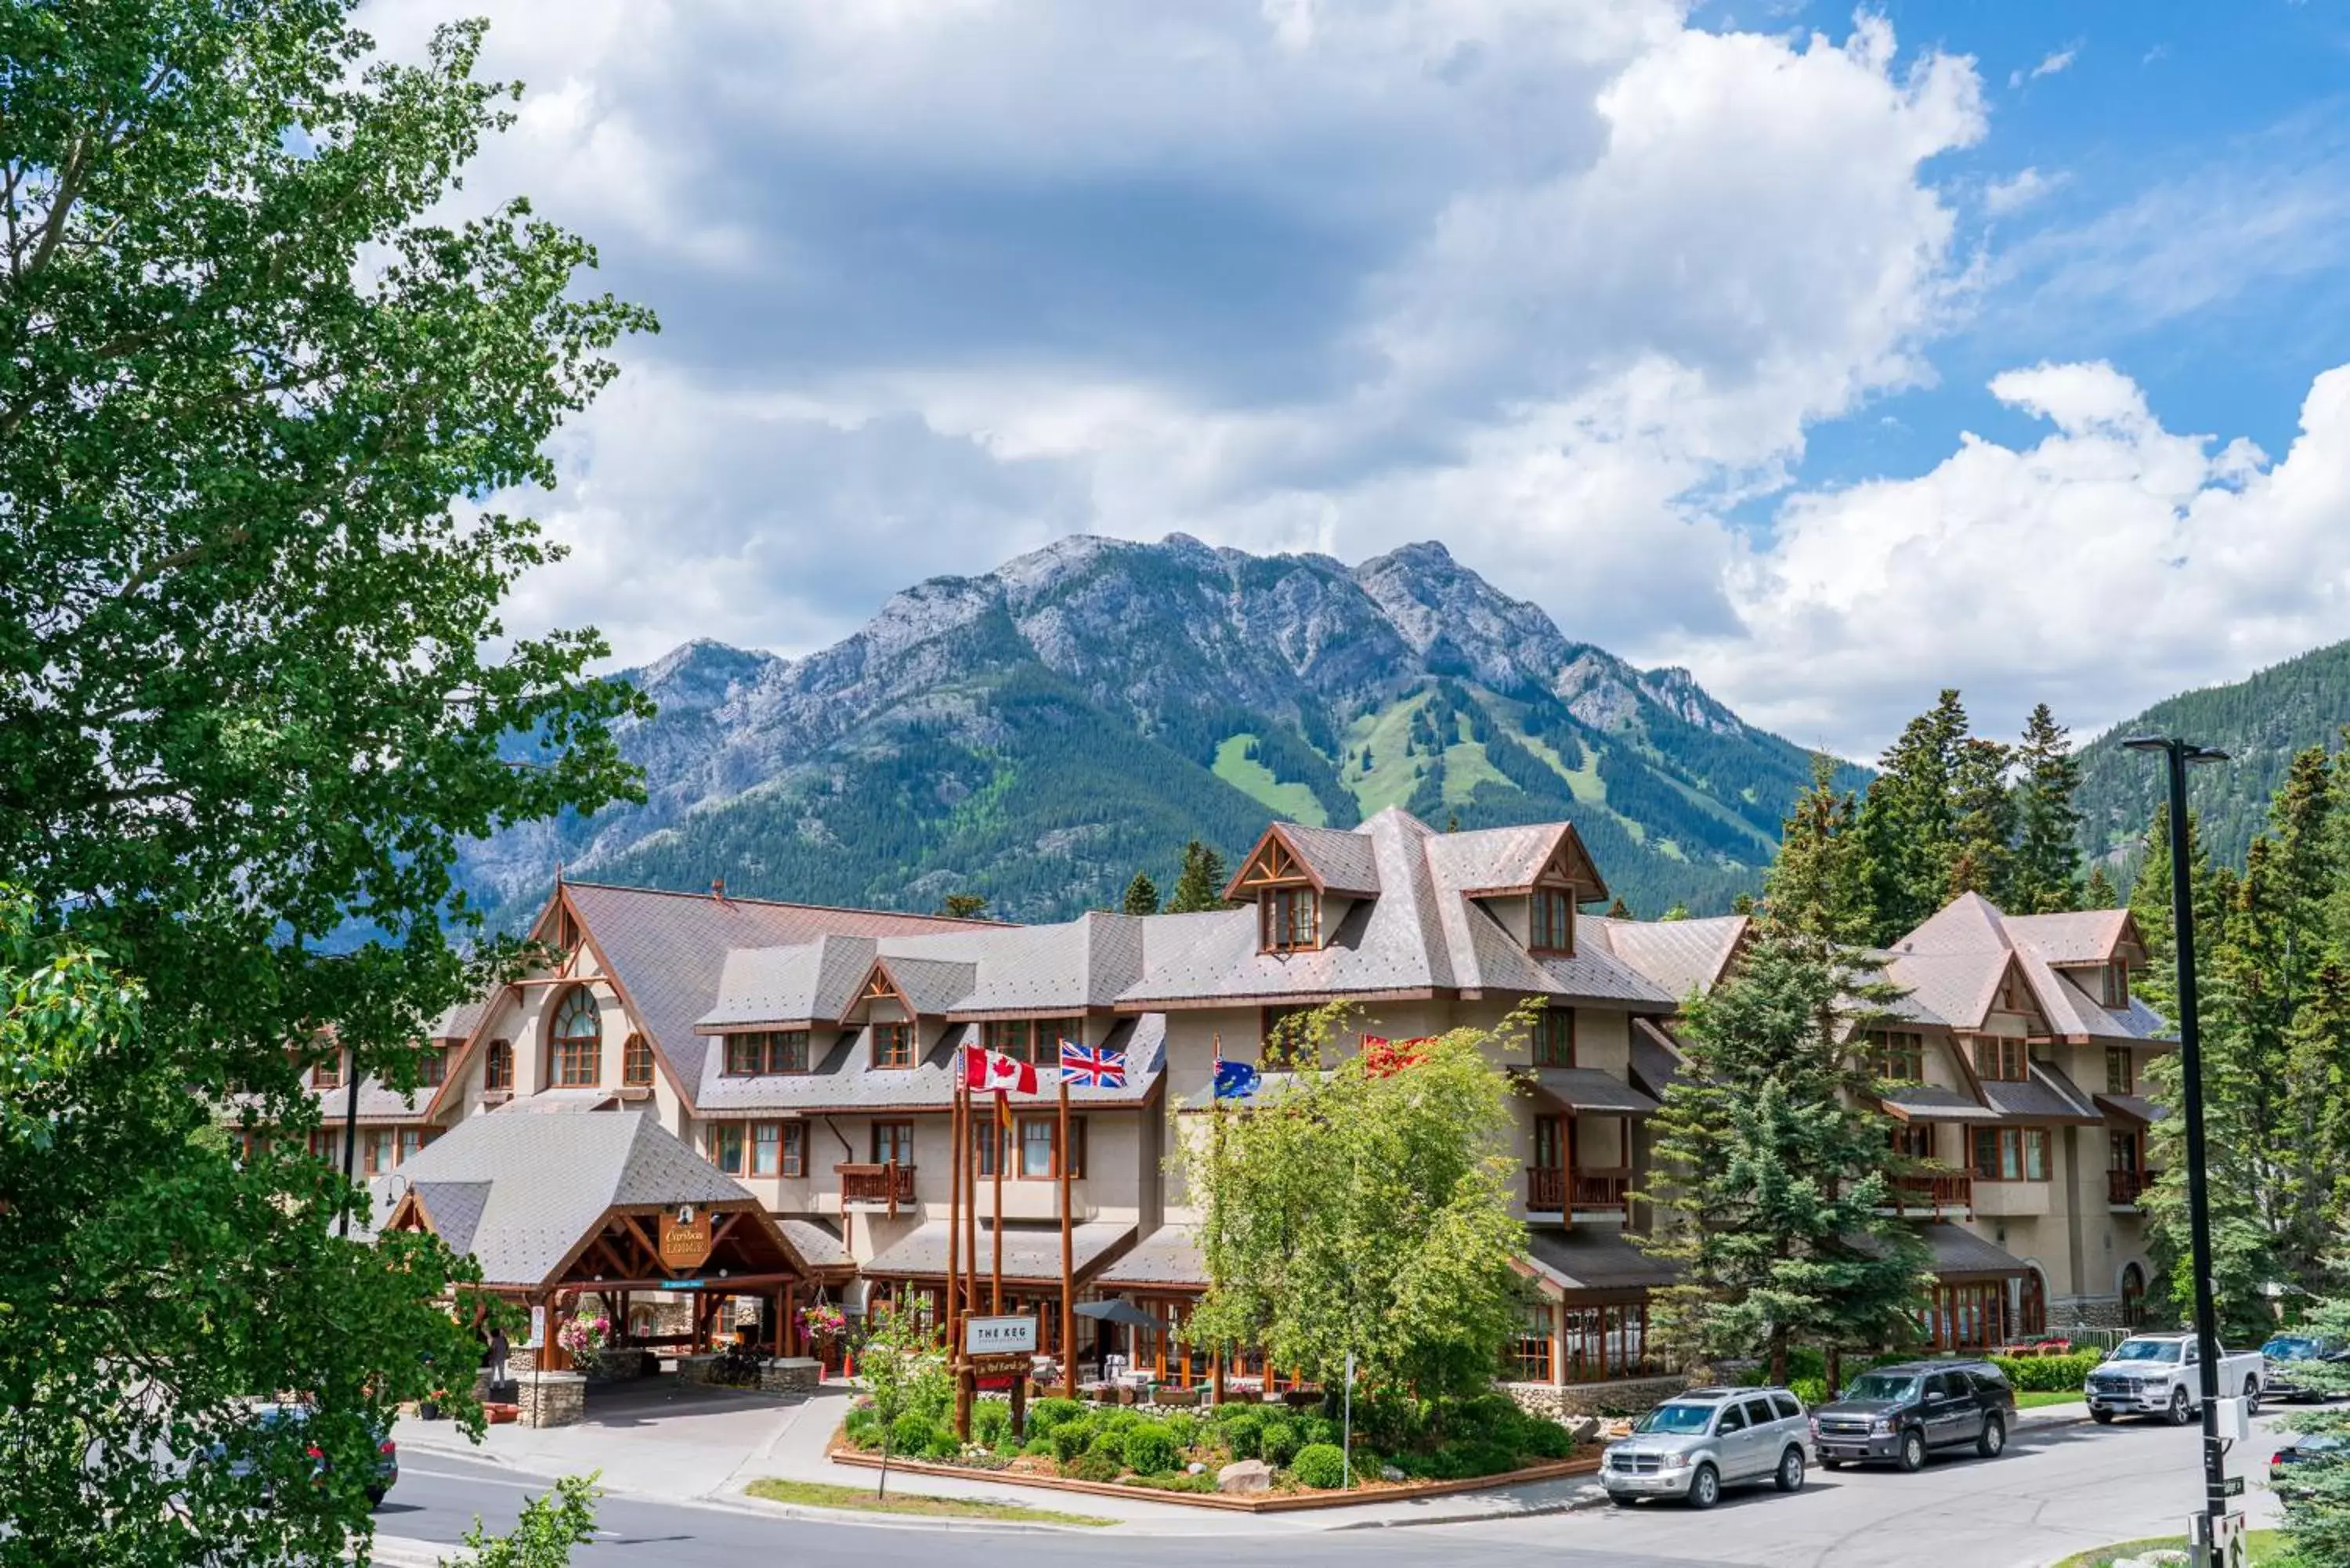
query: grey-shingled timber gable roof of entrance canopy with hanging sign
[{"left": 374, "top": 1110, "right": 822, "bottom": 1298}]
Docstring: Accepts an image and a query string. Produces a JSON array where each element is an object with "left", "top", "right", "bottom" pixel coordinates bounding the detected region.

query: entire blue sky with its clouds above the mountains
[{"left": 362, "top": 0, "right": 2350, "bottom": 754}]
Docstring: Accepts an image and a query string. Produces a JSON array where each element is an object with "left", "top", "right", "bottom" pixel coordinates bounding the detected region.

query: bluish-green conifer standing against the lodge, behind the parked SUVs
[{"left": 1640, "top": 926, "right": 1927, "bottom": 1382}]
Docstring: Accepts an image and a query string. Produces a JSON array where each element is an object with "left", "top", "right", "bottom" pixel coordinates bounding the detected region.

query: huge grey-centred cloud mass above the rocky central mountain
[{"left": 348, "top": 0, "right": 1986, "bottom": 681}]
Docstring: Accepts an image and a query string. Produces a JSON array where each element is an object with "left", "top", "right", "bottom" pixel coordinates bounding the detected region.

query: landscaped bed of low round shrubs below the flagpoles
[{"left": 834, "top": 1394, "right": 1598, "bottom": 1509}]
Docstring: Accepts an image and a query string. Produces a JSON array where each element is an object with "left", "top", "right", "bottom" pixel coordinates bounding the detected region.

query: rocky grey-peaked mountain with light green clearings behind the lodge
[{"left": 468, "top": 533, "right": 1861, "bottom": 919}]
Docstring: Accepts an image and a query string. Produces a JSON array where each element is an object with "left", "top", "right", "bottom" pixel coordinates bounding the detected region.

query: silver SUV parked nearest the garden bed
[{"left": 1600, "top": 1389, "right": 1812, "bottom": 1509}]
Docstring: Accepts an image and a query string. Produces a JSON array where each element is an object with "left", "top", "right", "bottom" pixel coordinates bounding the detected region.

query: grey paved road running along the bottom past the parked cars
[{"left": 376, "top": 1422, "right": 2280, "bottom": 1568}]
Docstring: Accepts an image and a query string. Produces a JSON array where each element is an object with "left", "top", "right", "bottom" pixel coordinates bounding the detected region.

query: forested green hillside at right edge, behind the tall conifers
[{"left": 2075, "top": 641, "right": 2350, "bottom": 875}]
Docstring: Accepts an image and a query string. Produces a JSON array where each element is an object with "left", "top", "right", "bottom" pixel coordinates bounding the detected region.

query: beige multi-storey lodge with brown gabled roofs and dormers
[{"left": 317, "top": 809, "right": 2164, "bottom": 1406}]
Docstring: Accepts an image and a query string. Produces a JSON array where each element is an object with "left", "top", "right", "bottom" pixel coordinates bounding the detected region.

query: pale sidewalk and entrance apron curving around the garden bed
[{"left": 392, "top": 1380, "right": 1605, "bottom": 1535}]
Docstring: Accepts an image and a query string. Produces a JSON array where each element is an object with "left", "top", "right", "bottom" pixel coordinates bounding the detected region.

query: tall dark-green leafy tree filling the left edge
[{"left": 0, "top": 0, "right": 651, "bottom": 1568}]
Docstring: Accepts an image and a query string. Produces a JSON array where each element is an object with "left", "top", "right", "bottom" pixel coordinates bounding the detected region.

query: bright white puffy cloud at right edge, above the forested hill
[{"left": 1692, "top": 364, "right": 2350, "bottom": 752}]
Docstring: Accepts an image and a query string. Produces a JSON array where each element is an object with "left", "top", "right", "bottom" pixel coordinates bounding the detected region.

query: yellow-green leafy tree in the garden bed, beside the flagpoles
[{"left": 1182, "top": 1009, "right": 1525, "bottom": 1399}]
